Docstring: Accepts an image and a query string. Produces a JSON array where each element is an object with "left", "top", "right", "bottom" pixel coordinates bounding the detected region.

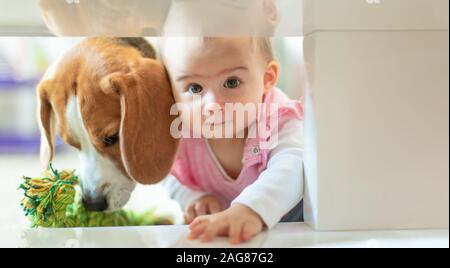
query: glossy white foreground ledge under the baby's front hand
[{"left": 0, "top": 223, "right": 449, "bottom": 248}]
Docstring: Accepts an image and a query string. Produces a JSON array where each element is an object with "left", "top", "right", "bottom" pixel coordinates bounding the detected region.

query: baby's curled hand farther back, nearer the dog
[{"left": 184, "top": 195, "right": 223, "bottom": 224}]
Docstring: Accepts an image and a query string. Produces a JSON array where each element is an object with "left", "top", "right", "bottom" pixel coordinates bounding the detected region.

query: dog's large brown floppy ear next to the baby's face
[{"left": 101, "top": 59, "right": 178, "bottom": 184}]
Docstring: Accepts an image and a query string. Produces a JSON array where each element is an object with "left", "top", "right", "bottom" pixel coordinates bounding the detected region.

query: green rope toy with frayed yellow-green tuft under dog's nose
[{"left": 20, "top": 165, "right": 173, "bottom": 228}]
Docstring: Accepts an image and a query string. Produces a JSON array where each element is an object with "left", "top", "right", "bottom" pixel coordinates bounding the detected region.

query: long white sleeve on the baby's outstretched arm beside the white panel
[{"left": 232, "top": 120, "right": 303, "bottom": 228}]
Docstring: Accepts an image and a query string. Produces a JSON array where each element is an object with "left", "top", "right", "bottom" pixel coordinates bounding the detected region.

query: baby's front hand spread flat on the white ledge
[{"left": 189, "top": 204, "right": 264, "bottom": 244}]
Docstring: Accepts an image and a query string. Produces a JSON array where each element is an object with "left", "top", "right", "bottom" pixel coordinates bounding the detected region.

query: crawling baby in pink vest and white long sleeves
[{"left": 161, "top": 37, "right": 303, "bottom": 244}]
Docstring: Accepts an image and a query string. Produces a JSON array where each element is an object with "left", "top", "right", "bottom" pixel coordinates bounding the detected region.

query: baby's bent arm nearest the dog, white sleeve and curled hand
[{"left": 163, "top": 175, "right": 223, "bottom": 224}]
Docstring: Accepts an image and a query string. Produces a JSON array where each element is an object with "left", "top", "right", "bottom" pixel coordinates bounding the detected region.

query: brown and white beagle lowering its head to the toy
[{"left": 37, "top": 38, "right": 178, "bottom": 211}]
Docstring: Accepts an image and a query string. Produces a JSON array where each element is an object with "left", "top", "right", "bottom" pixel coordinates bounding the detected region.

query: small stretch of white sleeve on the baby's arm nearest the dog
[{"left": 162, "top": 175, "right": 207, "bottom": 210}]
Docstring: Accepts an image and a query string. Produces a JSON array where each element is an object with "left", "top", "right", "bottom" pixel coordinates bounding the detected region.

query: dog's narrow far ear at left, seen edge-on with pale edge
[{"left": 37, "top": 82, "right": 55, "bottom": 169}]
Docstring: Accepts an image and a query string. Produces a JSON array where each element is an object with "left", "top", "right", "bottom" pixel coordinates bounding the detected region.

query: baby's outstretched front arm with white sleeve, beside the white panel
[{"left": 190, "top": 120, "right": 303, "bottom": 243}]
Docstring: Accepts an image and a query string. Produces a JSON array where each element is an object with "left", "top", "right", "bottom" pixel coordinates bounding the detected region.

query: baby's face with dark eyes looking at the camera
[{"left": 163, "top": 37, "right": 270, "bottom": 138}]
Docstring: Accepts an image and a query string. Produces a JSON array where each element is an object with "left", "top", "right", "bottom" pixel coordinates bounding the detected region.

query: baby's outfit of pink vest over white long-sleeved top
[{"left": 165, "top": 89, "right": 303, "bottom": 228}]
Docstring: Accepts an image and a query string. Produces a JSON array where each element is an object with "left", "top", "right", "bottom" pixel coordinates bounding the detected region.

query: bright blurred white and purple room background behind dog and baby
[{"left": 0, "top": 37, "right": 303, "bottom": 227}]
